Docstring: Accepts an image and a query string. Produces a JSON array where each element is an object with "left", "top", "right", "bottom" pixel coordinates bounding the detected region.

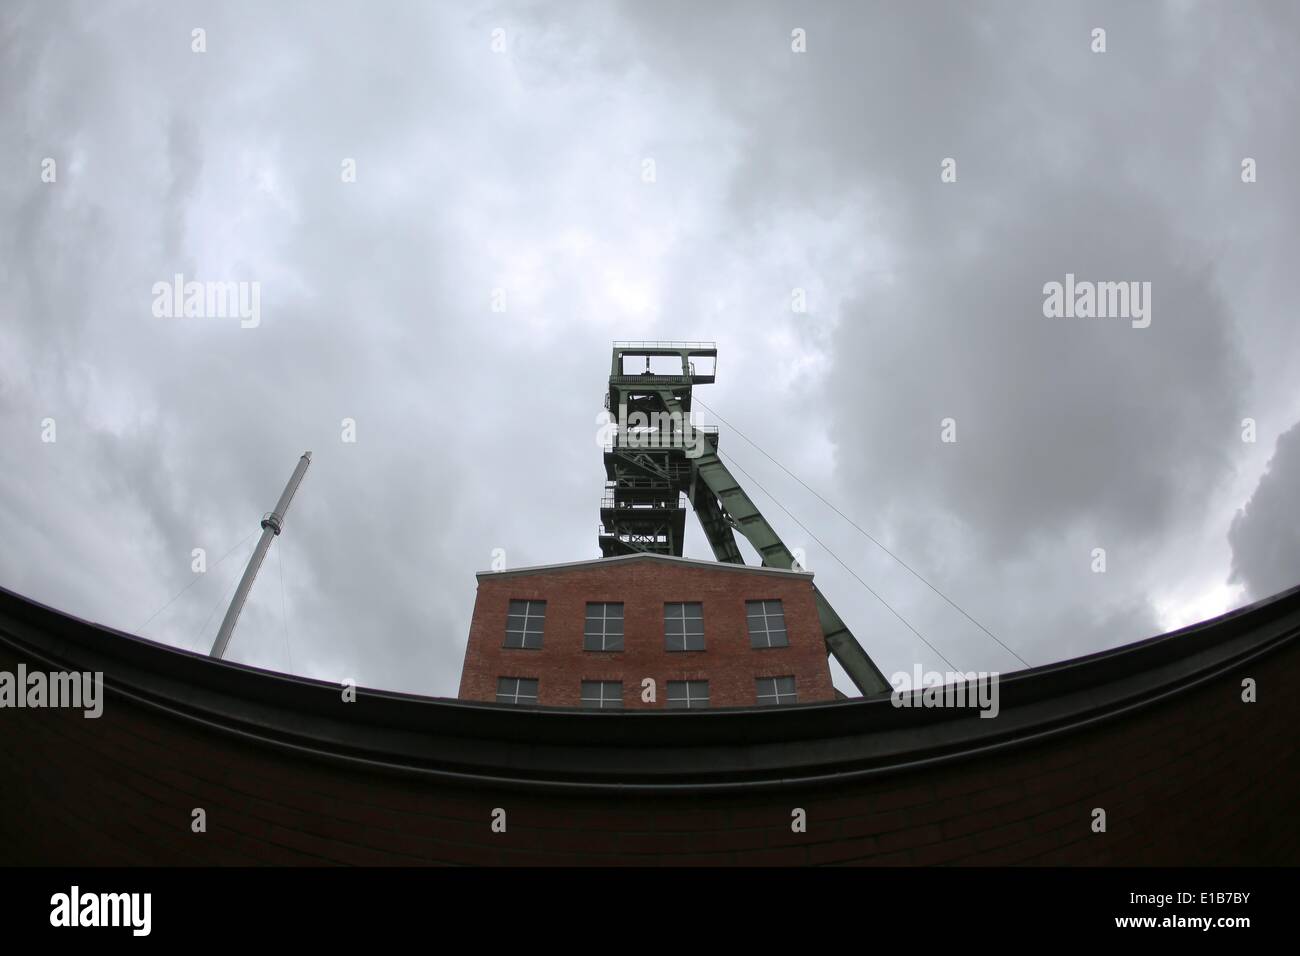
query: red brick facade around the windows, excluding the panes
[{"left": 459, "top": 554, "right": 835, "bottom": 709}]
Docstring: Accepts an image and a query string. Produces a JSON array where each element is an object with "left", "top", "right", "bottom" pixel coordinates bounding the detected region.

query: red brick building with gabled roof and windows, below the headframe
[{"left": 459, "top": 553, "right": 836, "bottom": 709}]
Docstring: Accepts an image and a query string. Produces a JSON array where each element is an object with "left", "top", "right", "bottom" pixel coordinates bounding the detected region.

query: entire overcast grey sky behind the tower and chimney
[{"left": 0, "top": 0, "right": 1300, "bottom": 696}]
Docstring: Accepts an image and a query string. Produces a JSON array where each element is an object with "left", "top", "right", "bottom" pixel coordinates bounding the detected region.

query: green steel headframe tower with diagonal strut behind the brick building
[{"left": 599, "top": 342, "right": 891, "bottom": 696}]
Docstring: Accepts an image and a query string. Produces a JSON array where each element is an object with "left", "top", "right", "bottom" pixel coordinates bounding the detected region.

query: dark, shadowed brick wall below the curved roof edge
[{"left": 0, "top": 634, "right": 1300, "bottom": 865}]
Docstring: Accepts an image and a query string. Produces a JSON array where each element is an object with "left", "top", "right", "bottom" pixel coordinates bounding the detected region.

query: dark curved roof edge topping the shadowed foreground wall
[{"left": 0, "top": 588, "right": 1300, "bottom": 791}]
